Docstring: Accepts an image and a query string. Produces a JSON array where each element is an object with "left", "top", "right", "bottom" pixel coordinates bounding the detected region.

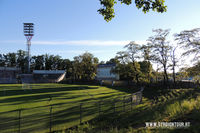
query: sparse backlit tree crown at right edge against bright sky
[{"left": 175, "top": 28, "right": 200, "bottom": 61}]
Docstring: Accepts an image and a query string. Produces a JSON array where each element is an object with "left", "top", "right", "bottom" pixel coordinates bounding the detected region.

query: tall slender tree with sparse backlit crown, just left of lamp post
[{"left": 147, "top": 29, "right": 171, "bottom": 83}]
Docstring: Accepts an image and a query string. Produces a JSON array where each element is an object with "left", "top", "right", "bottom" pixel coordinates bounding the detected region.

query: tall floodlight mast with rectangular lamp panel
[{"left": 24, "top": 23, "right": 34, "bottom": 73}]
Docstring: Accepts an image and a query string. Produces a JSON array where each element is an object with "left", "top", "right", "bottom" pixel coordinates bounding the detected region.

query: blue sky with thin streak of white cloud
[{"left": 0, "top": 0, "right": 200, "bottom": 64}]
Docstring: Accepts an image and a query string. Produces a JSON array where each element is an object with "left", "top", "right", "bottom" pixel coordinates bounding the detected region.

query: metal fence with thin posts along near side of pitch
[{"left": 0, "top": 89, "right": 143, "bottom": 133}]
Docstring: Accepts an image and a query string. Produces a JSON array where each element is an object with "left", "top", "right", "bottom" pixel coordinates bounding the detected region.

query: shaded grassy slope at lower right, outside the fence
[{"left": 66, "top": 88, "right": 200, "bottom": 133}]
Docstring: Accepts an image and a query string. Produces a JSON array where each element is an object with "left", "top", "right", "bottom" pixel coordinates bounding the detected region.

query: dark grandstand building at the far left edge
[{"left": 0, "top": 67, "right": 21, "bottom": 84}]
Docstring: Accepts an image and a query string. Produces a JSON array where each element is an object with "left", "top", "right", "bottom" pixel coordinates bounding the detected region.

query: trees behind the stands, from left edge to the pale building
[{"left": 0, "top": 50, "right": 99, "bottom": 80}]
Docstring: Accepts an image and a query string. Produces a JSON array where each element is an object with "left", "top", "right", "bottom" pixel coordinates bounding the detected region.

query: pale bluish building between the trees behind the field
[{"left": 96, "top": 64, "right": 119, "bottom": 80}]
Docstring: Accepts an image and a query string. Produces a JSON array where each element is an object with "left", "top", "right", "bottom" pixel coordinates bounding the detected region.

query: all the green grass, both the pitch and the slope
[{"left": 0, "top": 84, "right": 200, "bottom": 133}]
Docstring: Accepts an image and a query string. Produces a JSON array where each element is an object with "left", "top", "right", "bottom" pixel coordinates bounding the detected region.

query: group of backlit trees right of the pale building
[{"left": 110, "top": 28, "right": 200, "bottom": 84}]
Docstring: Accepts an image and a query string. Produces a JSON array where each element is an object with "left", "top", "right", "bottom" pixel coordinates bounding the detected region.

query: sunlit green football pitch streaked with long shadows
[{"left": 0, "top": 84, "right": 128, "bottom": 133}]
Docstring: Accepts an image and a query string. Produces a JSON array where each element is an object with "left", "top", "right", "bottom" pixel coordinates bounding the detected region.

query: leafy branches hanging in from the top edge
[{"left": 98, "top": 0, "right": 167, "bottom": 22}]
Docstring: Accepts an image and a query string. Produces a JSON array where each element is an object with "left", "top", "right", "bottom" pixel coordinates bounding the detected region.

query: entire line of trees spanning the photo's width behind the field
[{"left": 0, "top": 28, "right": 200, "bottom": 84}]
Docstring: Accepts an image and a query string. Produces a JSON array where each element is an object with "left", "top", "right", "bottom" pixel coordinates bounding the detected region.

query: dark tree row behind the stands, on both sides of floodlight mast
[{"left": 0, "top": 50, "right": 71, "bottom": 73}]
